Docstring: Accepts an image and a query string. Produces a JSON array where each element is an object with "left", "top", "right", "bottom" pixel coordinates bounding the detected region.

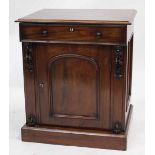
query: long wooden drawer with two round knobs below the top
[{"left": 20, "top": 24, "right": 126, "bottom": 43}]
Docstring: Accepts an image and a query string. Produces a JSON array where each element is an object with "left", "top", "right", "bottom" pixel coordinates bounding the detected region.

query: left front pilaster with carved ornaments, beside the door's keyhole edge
[{"left": 22, "top": 43, "right": 37, "bottom": 126}]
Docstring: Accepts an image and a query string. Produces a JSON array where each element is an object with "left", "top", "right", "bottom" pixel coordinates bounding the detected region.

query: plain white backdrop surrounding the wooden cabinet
[{"left": 9, "top": 0, "right": 145, "bottom": 155}]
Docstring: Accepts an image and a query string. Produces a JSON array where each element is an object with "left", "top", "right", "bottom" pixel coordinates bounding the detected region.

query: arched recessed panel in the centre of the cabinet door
[{"left": 49, "top": 54, "right": 99, "bottom": 119}]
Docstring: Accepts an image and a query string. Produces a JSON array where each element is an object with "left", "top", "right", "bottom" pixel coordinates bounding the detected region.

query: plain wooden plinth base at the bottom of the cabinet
[{"left": 21, "top": 105, "right": 133, "bottom": 150}]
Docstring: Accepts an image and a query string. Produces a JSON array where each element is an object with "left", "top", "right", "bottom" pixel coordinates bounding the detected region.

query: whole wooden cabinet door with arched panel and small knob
[{"left": 34, "top": 43, "right": 112, "bottom": 129}]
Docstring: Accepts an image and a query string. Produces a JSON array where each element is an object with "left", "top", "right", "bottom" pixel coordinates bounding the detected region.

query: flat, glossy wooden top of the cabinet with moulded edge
[{"left": 16, "top": 9, "right": 136, "bottom": 25}]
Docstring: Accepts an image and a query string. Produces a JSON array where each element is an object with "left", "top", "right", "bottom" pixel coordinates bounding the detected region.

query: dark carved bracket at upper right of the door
[{"left": 114, "top": 46, "right": 123, "bottom": 79}]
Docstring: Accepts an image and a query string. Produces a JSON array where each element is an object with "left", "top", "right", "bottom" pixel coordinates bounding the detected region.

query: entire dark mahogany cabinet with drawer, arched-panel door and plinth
[{"left": 17, "top": 9, "right": 136, "bottom": 150}]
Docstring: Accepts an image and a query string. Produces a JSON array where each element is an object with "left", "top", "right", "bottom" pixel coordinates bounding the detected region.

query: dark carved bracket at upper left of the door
[{"left": 24, "top": 43, "right": 33, "bottom": 73}]
